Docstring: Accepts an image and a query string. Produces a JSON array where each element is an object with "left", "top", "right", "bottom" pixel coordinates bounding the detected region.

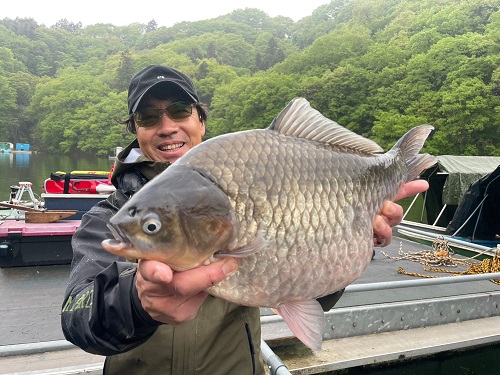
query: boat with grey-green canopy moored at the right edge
[{"left": 395, "top": 155, "right": 500, "bottom": 256}]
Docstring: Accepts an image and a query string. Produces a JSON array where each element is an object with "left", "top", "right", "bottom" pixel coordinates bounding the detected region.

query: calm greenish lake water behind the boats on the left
[{"left": 0, "top": 153, "right": 114, "bottom": 201}]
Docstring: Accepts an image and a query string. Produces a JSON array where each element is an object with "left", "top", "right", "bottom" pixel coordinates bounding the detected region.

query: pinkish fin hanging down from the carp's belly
[{"left": 273, "top": 300, "right": 326, "bottom": 351}]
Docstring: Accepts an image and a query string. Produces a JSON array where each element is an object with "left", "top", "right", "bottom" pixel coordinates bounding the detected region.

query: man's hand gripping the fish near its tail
[{"left": 373, "top": 180, "right": 429, "bottom": 246}]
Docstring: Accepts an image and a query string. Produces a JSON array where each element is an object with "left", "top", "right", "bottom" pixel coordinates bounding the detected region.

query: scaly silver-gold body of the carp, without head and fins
[{"left": 182, "top": 130, "right": 396, "bottom": 307}]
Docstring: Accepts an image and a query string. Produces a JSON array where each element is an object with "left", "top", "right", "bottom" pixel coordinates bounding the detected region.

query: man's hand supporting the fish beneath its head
[{"left": 136, "top": 258, "right": 238, "bottom": 324}]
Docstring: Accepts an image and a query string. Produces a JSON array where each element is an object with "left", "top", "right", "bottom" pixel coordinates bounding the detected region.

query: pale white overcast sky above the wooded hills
[{"left": 0, "top": 0, "right": 330, "bottom": 27}]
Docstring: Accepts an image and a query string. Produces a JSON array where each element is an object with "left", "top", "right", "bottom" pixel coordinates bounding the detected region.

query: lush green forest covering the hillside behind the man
[{"left": 0, "top": 0, "right": 500, "bottom": 156}]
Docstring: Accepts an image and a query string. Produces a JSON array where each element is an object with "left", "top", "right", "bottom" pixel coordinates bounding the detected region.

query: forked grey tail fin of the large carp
[{"left": 392, "top": 125, "right": 437, "bottom": 182}]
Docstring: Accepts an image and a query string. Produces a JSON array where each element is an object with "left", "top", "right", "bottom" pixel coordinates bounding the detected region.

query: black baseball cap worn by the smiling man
[{"left": 128, "top": 65, "right": 198, "bottom": 114}]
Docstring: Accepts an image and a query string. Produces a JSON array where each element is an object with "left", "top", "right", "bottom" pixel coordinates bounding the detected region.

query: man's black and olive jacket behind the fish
[{"left": 61, "top": 141, "right": 264, "bottom": 374}]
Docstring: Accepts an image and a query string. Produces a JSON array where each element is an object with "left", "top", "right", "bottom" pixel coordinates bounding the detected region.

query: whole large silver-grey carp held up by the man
[{"left": 103, "top": 98, "right": 436, "bottom": 350}]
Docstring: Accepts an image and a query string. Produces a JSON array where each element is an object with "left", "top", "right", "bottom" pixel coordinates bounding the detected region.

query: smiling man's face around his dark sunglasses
[{"left": 135, "top": 98, "right": 205, "bottom": 163}]
